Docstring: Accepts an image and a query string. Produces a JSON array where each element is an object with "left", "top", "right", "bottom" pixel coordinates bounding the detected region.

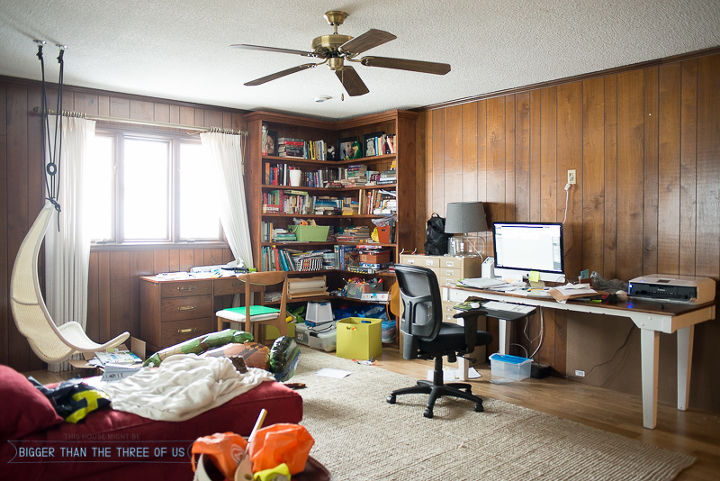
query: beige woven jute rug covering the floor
[{"left": 292, "top": 349, "right": 694, "bottom": 481}]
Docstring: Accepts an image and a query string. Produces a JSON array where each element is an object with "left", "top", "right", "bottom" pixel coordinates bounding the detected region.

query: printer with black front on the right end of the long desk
[{"left": 628, "top": 274, "right": 715, "bottom": 304}]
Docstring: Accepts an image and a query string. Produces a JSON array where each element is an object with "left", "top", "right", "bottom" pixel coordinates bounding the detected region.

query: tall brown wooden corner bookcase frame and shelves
[{"left": 245, "top": 110, "right": 417, "bottom": 322}]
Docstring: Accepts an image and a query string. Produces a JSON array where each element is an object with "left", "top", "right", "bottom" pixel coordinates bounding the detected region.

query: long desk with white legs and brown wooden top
[{"left": 443, "top": 286, "right": 715, "bottom": 429}]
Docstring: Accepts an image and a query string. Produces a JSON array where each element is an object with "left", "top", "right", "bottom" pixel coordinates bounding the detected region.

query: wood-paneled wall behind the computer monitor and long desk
[{"left": 424, "top": 53, "right": 720, "bottom": 411}]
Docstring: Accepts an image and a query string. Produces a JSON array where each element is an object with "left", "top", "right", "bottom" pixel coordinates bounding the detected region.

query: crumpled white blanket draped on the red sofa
[{"left": 98, "top": 354, "right": 274, "bottom": 421}]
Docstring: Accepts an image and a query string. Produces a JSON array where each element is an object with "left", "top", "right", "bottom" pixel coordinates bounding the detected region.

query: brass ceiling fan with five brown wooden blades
[{"left": 231, "top": 10, "right": 450, "bottom": 96}]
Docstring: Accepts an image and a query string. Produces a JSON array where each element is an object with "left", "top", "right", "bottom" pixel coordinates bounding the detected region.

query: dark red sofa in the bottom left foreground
[{"left": 0, "top": 365, "right": 302, "bottom": 481}]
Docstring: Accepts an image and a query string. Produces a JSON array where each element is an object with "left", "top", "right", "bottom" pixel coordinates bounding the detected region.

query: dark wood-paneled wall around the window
[{"left": 0, "top": 77, "right": 245, "bottom": 370}]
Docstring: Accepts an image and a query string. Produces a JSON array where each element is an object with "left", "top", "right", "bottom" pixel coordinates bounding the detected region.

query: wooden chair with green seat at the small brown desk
[{"left": 215, "top": 272, "right": 287, "bottom": 343}]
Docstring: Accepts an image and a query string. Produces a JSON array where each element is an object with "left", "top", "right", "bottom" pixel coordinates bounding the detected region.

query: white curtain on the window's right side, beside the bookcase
[{"left": 200, "top": 132, "right": 253, "bottom": 267}]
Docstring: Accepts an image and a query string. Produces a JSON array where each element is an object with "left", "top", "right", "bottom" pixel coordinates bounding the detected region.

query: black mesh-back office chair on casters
[{"left": 386, "top": 265, "right": 492, "bottom": 418}]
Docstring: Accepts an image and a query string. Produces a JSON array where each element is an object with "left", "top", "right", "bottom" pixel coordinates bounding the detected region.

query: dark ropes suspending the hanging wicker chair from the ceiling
[{"left": 35, "top": 40, "right": 67, "bottom": 218}]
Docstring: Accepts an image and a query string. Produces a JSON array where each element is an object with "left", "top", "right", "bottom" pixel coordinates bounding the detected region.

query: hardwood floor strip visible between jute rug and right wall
[{"left": 377, "top": 347, "right": 720, "bottom": 481}]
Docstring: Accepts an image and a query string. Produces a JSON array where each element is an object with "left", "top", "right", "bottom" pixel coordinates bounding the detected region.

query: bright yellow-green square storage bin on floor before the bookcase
[{"left": 335, "top": 317, "right": 382, "bottom": 360}]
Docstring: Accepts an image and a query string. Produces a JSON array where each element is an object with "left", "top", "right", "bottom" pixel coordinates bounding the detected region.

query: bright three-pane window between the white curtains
[{"left": 87, "top": 131, "right": 222, "bottom": 244}]
